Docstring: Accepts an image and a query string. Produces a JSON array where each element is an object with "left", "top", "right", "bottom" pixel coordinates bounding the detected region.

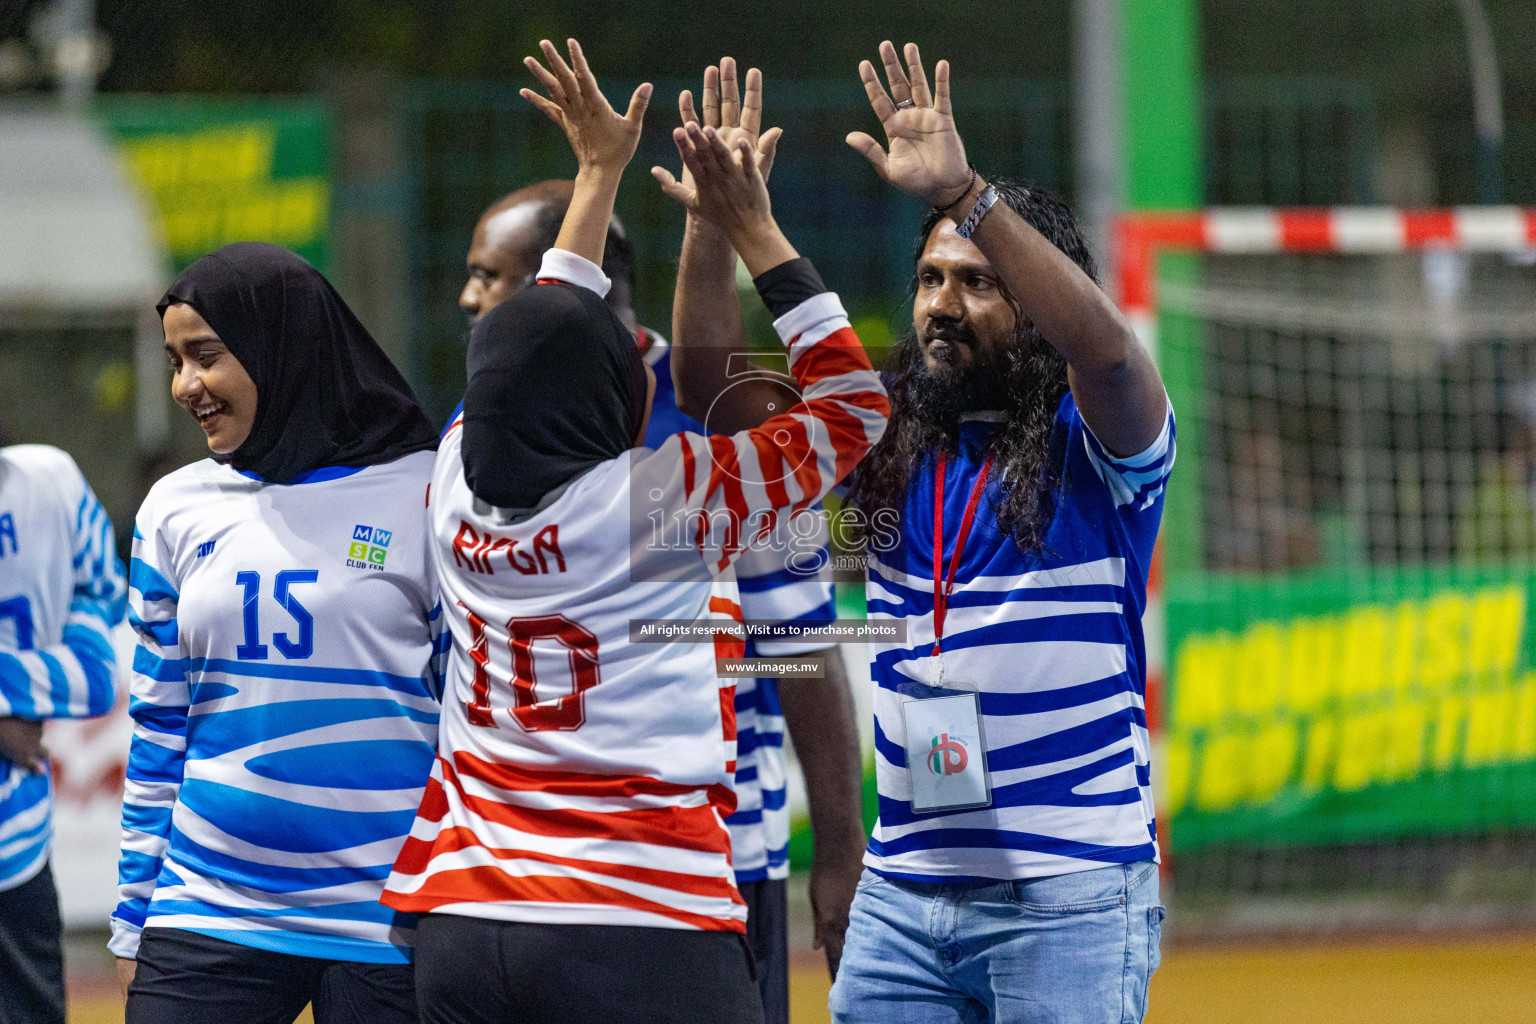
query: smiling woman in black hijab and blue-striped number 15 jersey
[{"left": 111, "top": 243, "right": 441, "bottom": 1024}]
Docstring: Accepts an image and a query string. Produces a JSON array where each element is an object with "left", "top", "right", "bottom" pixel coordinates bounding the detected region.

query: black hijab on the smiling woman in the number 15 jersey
[{"left": 155, "top": 241, "right": 438, "bottom": 484}]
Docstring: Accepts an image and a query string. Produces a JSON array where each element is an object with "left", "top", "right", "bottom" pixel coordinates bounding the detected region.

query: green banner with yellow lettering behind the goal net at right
[{"left": 1155, "top": 567, "right": 1536, "bottom": 852}]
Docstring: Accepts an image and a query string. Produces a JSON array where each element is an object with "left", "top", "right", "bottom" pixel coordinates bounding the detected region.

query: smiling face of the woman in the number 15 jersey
[{"left": 161, "top": 302, "right": 257, "bottom": 454}]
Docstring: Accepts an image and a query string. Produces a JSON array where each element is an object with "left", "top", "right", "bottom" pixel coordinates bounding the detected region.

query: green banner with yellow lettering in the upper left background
[{"left": 98, "top": 97, "right": 330, "bottom": 272}]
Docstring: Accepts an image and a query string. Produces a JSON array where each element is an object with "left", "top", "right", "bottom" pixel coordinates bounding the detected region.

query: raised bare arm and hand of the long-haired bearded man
[{"left": 848, "top": 41, "right": 1167, "bottom": 456}]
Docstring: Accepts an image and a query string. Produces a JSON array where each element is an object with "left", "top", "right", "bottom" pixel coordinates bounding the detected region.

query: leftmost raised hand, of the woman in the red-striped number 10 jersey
[{"left": 519, "top": 38, "right": 651, "bottom": 170}]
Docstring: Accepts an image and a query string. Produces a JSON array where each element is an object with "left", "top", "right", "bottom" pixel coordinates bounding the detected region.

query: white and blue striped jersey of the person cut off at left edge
[{"left": 0, "top": 445, "right": 124, "bottom": 890}]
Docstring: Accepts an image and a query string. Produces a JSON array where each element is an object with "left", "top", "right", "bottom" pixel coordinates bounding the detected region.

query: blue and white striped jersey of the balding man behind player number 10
[{"left": 725, "top": 505, "right": 837, "bottom": 883}]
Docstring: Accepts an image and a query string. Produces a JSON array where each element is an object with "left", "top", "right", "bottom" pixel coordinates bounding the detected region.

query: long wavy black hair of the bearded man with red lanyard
[{"left": 849, "top": 178, "right": 1098, "bottom": 553}]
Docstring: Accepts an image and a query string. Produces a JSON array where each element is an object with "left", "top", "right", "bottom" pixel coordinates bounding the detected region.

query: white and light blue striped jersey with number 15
[{"left": 111, "top": 451, "right": 447, "bottom": 963}]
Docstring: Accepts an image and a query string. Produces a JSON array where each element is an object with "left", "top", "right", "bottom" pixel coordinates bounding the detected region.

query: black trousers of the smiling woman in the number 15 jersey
[{"left": 126, "top": 927, "right": 416, "bottom": 1024}]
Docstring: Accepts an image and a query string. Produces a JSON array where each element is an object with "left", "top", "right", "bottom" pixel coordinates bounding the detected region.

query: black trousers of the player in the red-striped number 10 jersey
[{"left": 416, "top": 913, "right": 762, "bottom": 1024}]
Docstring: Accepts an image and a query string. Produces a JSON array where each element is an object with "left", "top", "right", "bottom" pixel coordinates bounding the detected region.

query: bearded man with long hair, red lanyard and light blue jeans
[{"left": 831, "top": 43, "right": 1174, "bottom": 1024}]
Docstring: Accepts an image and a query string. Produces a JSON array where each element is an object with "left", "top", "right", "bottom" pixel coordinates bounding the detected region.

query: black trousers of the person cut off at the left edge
[{"left": 0, "top": 864, "right": 65, "bottom": 1024}]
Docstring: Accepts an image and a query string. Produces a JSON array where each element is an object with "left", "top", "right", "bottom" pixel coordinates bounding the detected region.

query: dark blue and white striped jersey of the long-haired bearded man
[{"left": 865, "top": 395, "right": 1175, "bottom": 881}]
